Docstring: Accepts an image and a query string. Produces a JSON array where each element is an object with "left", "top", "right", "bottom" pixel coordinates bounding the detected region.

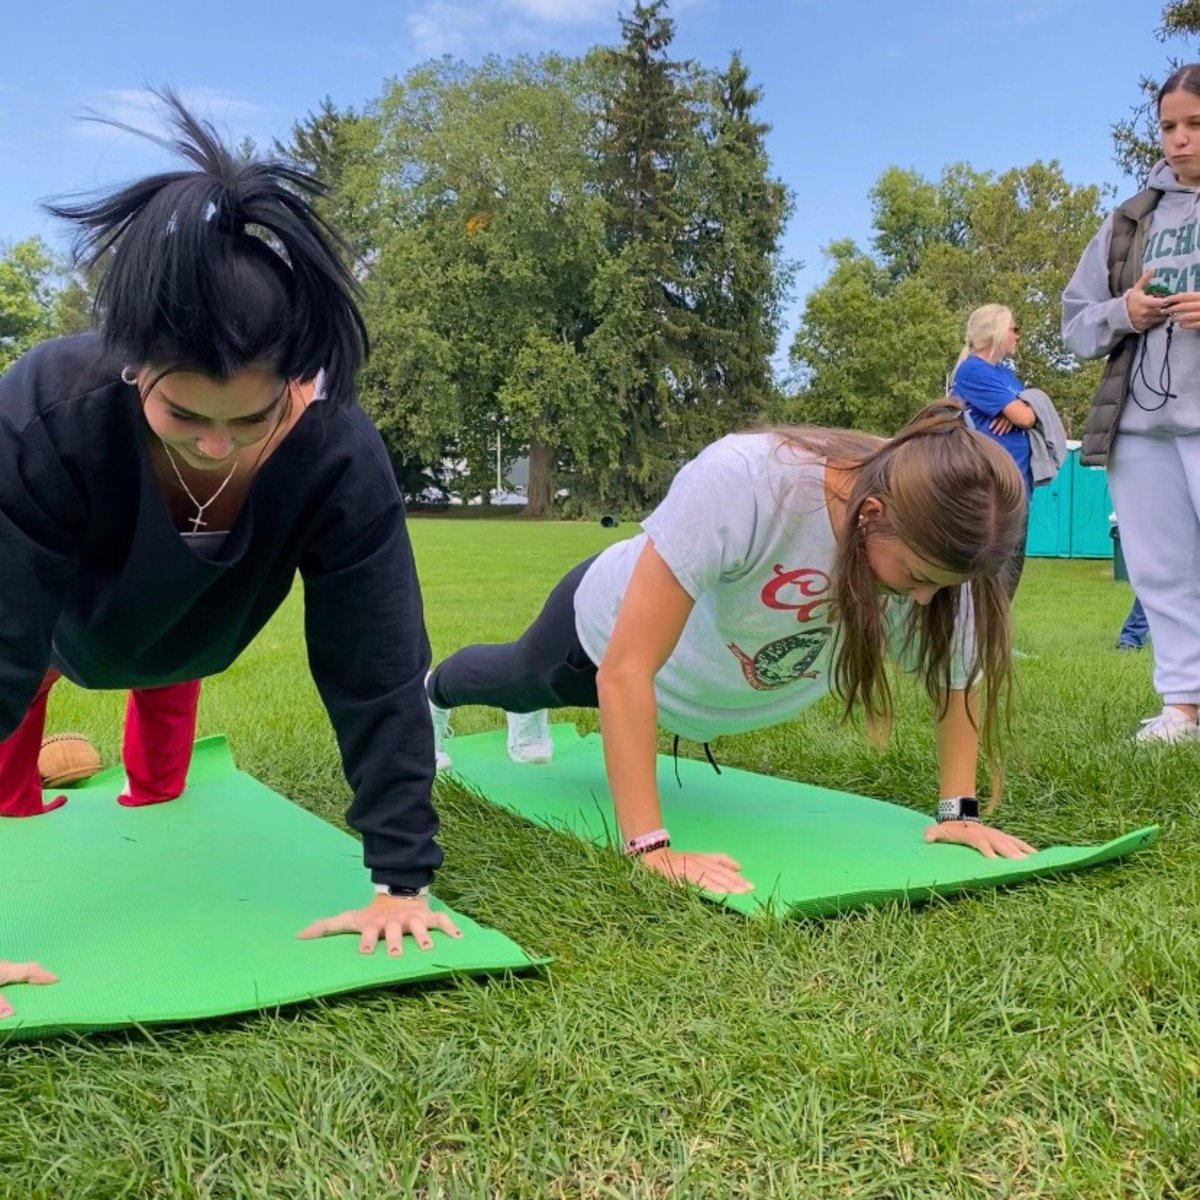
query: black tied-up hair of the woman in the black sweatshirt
[{"left": 47, "top": 90, "right": 368, "bottom": 403}]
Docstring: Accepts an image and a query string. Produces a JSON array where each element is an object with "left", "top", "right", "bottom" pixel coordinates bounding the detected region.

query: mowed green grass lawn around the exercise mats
[{"left": 0, "top": 518, "right": 1200, "bottom": 1200}]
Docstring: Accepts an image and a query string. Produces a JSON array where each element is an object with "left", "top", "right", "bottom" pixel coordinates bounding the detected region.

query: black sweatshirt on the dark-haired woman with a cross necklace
[{"left": 0, "top": 334, "right": 442, "bottom": 887}]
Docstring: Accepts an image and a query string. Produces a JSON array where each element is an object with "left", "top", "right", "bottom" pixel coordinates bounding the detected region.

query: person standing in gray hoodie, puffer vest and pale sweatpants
[{"left": 1062, "top": 64, "right": 1200, "bottom": 743}]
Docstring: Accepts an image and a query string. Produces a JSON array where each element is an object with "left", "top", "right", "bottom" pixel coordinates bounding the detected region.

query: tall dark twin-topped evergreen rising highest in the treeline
[{"left": 583, "top": 0, "right": 788, "bottom": 510}]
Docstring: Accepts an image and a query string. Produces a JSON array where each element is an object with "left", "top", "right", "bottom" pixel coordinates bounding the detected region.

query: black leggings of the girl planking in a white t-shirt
[{"left": 428, "top": 556, "right": 600, "bottom": 713}]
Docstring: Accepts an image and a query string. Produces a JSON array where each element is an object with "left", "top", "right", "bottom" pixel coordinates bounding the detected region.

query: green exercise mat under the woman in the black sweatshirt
[{"left": 0, "top": 737, "right": 545, "bottom": 1040}]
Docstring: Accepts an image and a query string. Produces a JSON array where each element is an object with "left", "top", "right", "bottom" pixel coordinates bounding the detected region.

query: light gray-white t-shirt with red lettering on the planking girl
[{"left": 575, "top": 433, "right": 970, "bottom": 742}]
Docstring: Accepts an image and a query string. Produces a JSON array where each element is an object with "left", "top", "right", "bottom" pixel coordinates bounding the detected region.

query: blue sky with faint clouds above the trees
[{"left": 0, "top": 0, "right": 1180, "bottom": 355}]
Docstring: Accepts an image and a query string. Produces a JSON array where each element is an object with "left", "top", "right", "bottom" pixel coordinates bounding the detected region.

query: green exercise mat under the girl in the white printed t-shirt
[{"left": 446, "top": 725, "right": 1158, "bottom": 917}]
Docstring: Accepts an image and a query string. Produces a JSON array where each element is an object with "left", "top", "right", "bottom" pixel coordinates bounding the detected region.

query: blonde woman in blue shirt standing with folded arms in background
[{"left": 948, "top": 304, "right": 1037, "bottom": 596}]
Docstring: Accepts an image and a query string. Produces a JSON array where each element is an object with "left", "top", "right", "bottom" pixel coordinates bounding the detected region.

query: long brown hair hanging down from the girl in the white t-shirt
[{"left": 774, "top": 397, "right": 1026, "bottom": 799}]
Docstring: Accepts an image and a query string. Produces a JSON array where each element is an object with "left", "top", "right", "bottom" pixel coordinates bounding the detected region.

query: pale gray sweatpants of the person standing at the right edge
[{"left": 1109, "top": 433, "right": 1200, "bottom": 704}]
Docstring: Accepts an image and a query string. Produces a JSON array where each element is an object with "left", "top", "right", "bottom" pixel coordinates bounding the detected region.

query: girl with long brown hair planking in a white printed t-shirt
[{"left": 427, "top": 400, "right": 1032, "bottom": 892}]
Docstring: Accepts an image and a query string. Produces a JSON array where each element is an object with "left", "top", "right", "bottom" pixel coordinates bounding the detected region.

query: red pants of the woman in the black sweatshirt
[{"left": 0, "top": 670, "right": 200, "bottom": 817}]
